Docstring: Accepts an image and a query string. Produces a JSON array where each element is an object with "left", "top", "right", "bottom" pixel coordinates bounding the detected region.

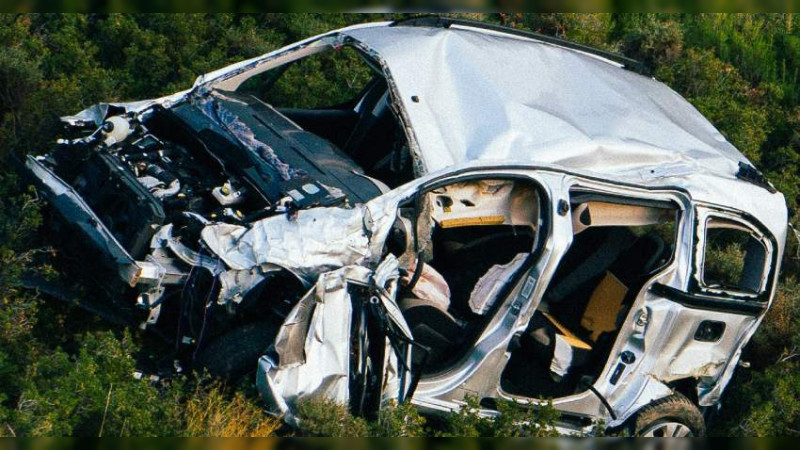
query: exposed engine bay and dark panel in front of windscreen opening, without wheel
[{"left": 43, "top": 90, "right": 385, "bottom": 259}]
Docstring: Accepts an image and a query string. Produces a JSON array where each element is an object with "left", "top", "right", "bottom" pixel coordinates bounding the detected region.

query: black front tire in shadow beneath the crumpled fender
[{"left": 194, "top": 321, "right": 279, "bottom": 382}]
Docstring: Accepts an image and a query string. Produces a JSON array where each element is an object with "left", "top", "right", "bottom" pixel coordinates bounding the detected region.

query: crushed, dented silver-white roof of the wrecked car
[{"left": 341, "top": 24, "right": 786, "bottom": 241}]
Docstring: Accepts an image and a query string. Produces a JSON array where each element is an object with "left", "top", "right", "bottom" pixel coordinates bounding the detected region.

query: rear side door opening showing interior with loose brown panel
[{"left": 501, "top": 195, "right": 678, "bottom": 398}]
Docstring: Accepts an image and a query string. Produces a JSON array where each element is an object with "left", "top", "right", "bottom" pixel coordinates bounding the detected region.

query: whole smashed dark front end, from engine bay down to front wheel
[{"left": 26, "top": 91, "right": 400, "bottom": 366}]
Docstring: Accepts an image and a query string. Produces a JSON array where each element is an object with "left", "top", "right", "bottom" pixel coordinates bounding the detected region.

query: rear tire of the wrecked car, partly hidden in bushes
[{"left": 630, "top": 393, "right": 706, "bottom": 437}]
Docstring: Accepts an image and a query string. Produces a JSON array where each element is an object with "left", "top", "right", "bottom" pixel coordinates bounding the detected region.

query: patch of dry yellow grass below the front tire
[{"left": 185, "top": 384, "right": 281, "bottom": 437}]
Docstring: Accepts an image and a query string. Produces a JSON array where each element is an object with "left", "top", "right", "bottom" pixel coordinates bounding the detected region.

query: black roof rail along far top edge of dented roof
[{"left": 389, "top": 15, "right": 652, "bottom": 76}]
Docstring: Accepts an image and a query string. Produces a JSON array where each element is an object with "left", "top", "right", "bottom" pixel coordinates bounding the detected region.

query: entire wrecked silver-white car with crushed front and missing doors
[{"left": 26, "top": 18, "right": 787, "bottom": 436}]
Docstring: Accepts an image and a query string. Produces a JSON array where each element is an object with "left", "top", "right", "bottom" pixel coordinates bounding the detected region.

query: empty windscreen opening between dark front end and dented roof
[{"left": 236, "top": 46, "right": 414, "bottom": 187}]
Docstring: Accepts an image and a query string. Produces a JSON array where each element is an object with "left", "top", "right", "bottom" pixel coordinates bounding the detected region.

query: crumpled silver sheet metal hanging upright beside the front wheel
[{"left": 257, "top": 256, "right": 411, "bottom": 425}]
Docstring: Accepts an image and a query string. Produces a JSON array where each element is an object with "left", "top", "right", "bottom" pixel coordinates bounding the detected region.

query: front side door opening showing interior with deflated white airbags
[{"left": 384, "top": 179, "right": 541, "bottom": 374}]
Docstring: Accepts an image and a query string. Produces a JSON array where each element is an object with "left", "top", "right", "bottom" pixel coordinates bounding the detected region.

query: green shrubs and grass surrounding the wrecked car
[{"left": 0, "top": 14, "right": 800, "bottom": 436}]
